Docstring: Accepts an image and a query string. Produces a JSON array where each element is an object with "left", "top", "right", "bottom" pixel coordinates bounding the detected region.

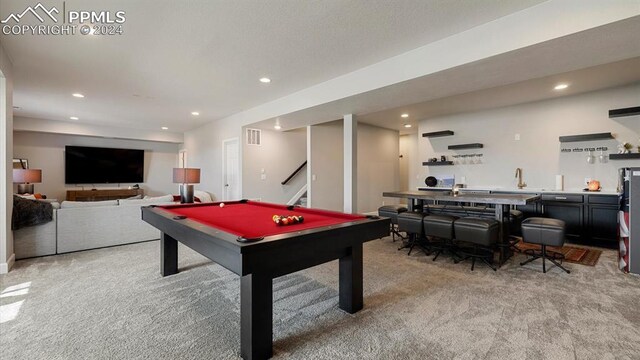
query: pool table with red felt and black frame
[{"left": 142, "top": 200, "right": 389, "bottom": 359}]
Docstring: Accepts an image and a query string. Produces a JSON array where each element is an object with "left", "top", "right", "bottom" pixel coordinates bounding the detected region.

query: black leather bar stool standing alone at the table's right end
[{"left": 520, "top": 217, "right": 571, "bottom": 274}]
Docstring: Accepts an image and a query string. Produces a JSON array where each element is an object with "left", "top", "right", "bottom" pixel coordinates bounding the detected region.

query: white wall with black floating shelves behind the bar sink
[{"left": 410, "top": 83, "right": 640, "bottom": 190}]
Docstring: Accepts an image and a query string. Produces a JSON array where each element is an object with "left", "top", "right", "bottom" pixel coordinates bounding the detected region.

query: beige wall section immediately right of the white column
[{"left": 357, "top": 123, "right": 400, "bottom": 213}]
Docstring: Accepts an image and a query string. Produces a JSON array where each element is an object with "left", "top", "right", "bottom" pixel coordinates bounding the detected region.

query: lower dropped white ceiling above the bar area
[{"left": 252, "top": 17, "right": 640, "bottom": 134}]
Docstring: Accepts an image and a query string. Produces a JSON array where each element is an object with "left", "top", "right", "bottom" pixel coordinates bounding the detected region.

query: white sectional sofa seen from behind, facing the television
[{"left": 13, "top": 195, "right": 188, "bottom": 259}]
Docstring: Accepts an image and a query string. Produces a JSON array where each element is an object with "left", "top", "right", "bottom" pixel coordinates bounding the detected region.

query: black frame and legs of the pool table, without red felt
[{"left": 142, "top": 202, "right": 389, "bottom": 359}]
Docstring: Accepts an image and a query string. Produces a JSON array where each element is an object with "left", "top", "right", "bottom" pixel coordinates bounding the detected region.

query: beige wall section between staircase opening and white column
[{"left": 309, "top": 120, "right": 344, "bottom": 211}]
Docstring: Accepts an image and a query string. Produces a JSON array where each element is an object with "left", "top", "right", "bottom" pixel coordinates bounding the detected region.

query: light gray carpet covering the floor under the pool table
[{"left": 0, "top": 238, "right": 640, "bottom": 360}]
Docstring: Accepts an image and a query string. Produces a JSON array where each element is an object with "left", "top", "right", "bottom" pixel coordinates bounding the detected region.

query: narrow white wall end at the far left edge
[{"left": 0, "top": 44, "right": 15, "bottom": 274}]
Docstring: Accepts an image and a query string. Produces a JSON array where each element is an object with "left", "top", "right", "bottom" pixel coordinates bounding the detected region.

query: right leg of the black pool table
[{"left": 339, "top": 243, "right": 363, "bottom": 314}]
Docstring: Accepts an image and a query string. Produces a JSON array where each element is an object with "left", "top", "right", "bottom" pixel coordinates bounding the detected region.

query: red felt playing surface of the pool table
[{"left": 157, "top": 201, "right": 365, "bottom": 238}]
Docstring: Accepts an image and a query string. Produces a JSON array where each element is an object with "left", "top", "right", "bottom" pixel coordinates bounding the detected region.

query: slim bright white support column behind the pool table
[{"left": 343, "top": 114, "right": 358, "bottom": 213}]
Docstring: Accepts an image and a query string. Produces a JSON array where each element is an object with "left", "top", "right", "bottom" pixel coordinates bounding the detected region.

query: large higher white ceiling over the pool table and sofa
[{"left": 0, "top": 0, "right": 543, "bottom": 132}]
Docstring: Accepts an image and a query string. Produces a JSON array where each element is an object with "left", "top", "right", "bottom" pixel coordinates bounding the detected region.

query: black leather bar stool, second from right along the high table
[{"left": 453, "top": 217, "right": 500, "bottom": 271}]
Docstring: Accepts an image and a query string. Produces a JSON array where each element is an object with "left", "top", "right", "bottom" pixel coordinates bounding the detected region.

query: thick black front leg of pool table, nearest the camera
[{"left": 240, "top": 274, "right": 273, "bottom": 360}]
